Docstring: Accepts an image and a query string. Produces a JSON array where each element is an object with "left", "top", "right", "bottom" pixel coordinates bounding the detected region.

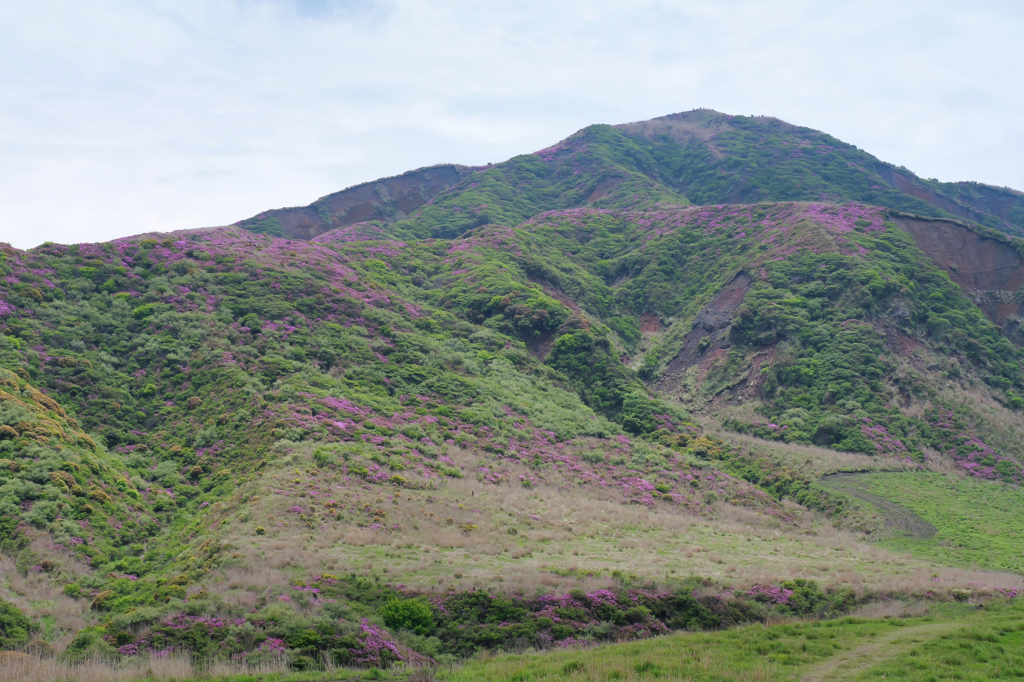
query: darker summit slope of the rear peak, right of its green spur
[{"left": 616, "top": 110, "right": 1024, "bottom": 237}]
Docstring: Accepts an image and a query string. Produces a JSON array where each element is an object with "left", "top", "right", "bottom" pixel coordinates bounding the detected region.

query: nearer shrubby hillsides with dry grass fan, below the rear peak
[{"left": 0, "top": 196, "right": 1020, "bottom": 666}]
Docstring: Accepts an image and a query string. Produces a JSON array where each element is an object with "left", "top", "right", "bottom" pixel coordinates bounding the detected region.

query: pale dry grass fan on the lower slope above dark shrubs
[{"left": 184, "top": 428, "right": 1020, "bottom": 606}]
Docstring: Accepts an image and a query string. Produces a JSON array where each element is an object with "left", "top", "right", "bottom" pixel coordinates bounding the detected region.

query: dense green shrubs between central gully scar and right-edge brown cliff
[{"left": 730, "top": 222, "right": 1022, "bottom": 456}]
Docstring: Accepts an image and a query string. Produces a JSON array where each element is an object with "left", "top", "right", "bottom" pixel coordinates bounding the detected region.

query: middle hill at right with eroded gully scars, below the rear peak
[{"left": 385, "top": 204, "right": 1024, "bottom": 481}]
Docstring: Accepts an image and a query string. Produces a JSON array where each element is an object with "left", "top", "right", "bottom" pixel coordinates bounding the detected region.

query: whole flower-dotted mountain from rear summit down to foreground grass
[{"left": 0, "top": 111, "right": 1024, "bottom": 670}]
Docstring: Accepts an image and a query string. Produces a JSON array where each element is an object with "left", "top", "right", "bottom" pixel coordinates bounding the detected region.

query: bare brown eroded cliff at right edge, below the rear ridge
[{"left": 893, "top": 215, "right": 1024, "bottom": 343}]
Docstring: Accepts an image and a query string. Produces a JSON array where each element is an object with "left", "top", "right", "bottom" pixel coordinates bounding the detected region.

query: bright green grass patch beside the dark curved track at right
[{"left": 823, "top": 472, "right": 1024, "bottom": 571}]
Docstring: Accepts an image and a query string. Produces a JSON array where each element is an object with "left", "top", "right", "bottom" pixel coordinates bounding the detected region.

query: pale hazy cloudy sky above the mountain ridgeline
[{"left": 0, "top": 0, "right": 1024, "bottom": 248}]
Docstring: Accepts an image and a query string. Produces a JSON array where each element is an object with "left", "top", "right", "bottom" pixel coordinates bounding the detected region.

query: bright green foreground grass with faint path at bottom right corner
[{"left": 438, "top": 603, "right": 1024, "bottom": 682}]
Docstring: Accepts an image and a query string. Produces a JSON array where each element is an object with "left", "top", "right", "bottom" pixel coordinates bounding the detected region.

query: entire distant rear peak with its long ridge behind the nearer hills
[{"left": 236, "top": 110, "right": 1024, "bottom": 239}]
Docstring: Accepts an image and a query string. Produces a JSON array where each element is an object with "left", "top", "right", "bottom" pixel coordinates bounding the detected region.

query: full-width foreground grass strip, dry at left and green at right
[{"left": 6, "top": 601, "right": 1024, "bottom": 682}]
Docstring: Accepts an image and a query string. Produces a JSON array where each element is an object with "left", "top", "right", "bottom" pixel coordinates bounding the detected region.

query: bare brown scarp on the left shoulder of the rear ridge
[{"left": 237, "top": 165, "right": 469, "bottom": 240}]
